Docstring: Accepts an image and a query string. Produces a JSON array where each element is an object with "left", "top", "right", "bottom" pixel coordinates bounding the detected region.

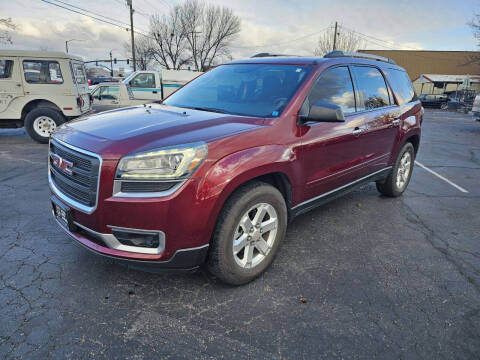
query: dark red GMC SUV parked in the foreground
[{"left": 48, "top": 52, "right": 423, "bottom": 284}]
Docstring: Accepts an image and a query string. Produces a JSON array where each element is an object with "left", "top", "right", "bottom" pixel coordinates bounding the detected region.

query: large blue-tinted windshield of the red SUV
[{"left": 164, "top": 64, "right": 311, "bottom": 117}]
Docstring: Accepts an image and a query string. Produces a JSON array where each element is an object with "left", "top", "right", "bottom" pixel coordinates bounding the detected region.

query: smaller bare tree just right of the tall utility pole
[{"left": 150, "top": 5, "right": 191, "bottom": 70}]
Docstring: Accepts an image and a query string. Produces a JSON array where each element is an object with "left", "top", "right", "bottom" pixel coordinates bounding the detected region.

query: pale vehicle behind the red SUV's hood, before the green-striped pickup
[{"left": 92, "top": 83, "right": 151, "bottom": 112}]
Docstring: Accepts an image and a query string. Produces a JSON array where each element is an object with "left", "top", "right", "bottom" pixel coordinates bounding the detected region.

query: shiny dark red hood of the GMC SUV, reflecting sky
[{"left": 54, "top": 104, "right": 264, "bottom": 159}]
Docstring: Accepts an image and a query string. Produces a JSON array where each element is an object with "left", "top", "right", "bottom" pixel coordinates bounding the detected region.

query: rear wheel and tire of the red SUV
[{"left": 377, "top": 142, "right": 415, "bottom": 197}]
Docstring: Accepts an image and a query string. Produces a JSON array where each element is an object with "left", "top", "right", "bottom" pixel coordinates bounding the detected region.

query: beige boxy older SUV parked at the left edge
[{"left": 0, "top": 50, "right": 91, "bottom": 143}]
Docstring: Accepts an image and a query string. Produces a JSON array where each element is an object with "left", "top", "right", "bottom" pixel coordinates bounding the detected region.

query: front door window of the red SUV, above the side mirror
[{"left": 301, "top": 66, "right": 355, "bottom": 114}]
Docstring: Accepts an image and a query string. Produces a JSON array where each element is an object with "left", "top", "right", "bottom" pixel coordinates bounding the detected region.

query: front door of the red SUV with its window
[{"left": 300, "top": 66, "right": 368, "bottom": 201}]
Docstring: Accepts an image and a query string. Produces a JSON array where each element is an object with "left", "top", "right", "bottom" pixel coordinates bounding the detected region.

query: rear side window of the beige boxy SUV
[{"left": 23, "top": 60, "right": 63, "bottom": 84}]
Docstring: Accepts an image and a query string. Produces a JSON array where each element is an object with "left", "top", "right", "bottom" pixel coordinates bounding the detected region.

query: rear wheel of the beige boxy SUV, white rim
[{"left": 24, "top": 107, "right": 65, "bottom": 144}]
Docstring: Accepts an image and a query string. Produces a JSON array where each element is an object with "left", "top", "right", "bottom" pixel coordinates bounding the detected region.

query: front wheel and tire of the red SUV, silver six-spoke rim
[{"left": 207, "top": 181, "right": 287, "bottom": 285}]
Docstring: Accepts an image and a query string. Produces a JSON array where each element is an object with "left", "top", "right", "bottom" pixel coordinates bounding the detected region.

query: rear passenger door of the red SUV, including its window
[{"left": 350, "top": 65, "right": 400, "bottom": 173}]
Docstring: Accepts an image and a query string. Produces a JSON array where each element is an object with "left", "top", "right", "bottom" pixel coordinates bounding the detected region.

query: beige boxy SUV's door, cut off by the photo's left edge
[{"left": 0, "top": 57, "right": 23, "bottom": 118}]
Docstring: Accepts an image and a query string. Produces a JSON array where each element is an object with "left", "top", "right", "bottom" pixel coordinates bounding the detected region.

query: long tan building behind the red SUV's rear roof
[{"left": 359, "top": 50, "right": 480, "bottom": 81}]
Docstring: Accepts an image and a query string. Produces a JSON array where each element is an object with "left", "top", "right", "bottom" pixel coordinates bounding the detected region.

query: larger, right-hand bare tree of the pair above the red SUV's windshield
[{"left": 181, "top": 0, "right": 240, "bottom": 71}]
